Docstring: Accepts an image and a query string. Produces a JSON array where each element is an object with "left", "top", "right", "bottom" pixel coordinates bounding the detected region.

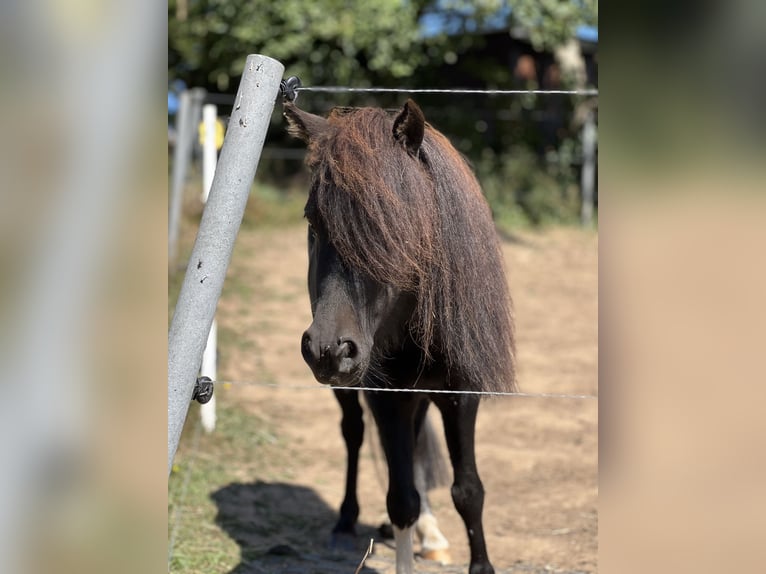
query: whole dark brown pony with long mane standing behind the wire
[{"left": 284, "top": 100, "right": 515, "bottom": 574}]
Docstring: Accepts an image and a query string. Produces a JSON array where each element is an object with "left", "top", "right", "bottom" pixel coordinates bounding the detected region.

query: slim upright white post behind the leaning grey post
[{"left": 200, "top": 104, "right": 218, "bottom": 433}]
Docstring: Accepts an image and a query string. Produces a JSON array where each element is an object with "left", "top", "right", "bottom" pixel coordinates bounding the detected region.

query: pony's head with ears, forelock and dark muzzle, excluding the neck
[{"left": 285, "top": 101, "right": 430, "bottom": 385}]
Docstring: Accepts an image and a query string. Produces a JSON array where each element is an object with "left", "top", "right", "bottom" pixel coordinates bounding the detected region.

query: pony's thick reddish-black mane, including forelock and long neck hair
[{"left": 307, "top": 108, "right": 516, "bottom": 391}]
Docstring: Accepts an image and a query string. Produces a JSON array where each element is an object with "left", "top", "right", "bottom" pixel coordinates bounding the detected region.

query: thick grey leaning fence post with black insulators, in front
[{"left": 168, "top": 54, "right": 284, "bottom": 474}]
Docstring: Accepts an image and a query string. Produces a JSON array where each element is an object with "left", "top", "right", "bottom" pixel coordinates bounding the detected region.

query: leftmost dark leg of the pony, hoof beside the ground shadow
[{"left": 330, "top": 391, "right": 364, "bottom": 550}]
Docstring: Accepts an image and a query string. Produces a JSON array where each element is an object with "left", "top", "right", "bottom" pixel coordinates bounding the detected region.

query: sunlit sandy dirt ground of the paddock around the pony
[{"left": 211, "top": 226, "right": 598, "bottom": 573}]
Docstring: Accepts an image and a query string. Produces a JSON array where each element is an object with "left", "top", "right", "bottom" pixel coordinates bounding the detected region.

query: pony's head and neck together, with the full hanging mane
[{"left": 284, "top": 100, "right": 513, "bottom": 390}]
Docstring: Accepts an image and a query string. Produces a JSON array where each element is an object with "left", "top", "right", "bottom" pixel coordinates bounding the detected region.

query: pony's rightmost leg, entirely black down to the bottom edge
[{"left": 434, "top": 395, "right": 495, "bottom": 574}]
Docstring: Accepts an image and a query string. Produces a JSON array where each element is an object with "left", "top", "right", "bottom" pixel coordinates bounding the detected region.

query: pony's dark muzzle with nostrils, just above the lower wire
[{"left": 301, "top": 328, "right": 361, "bottom": 385}]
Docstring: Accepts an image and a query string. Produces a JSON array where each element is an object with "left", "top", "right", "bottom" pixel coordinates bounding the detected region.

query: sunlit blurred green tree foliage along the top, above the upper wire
[{"left": 168, "top": 0, "right": 598, "bottom": 91}]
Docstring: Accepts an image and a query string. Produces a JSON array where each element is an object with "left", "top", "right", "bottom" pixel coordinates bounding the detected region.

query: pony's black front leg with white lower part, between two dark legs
[{"left": 368, "top": 392, "right": 422, "bottom": 574}]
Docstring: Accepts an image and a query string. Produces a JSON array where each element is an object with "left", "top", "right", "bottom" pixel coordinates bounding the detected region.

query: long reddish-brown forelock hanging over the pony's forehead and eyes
[{"left": 309, "top": 108, "right": 437, "bottom": 291}]
